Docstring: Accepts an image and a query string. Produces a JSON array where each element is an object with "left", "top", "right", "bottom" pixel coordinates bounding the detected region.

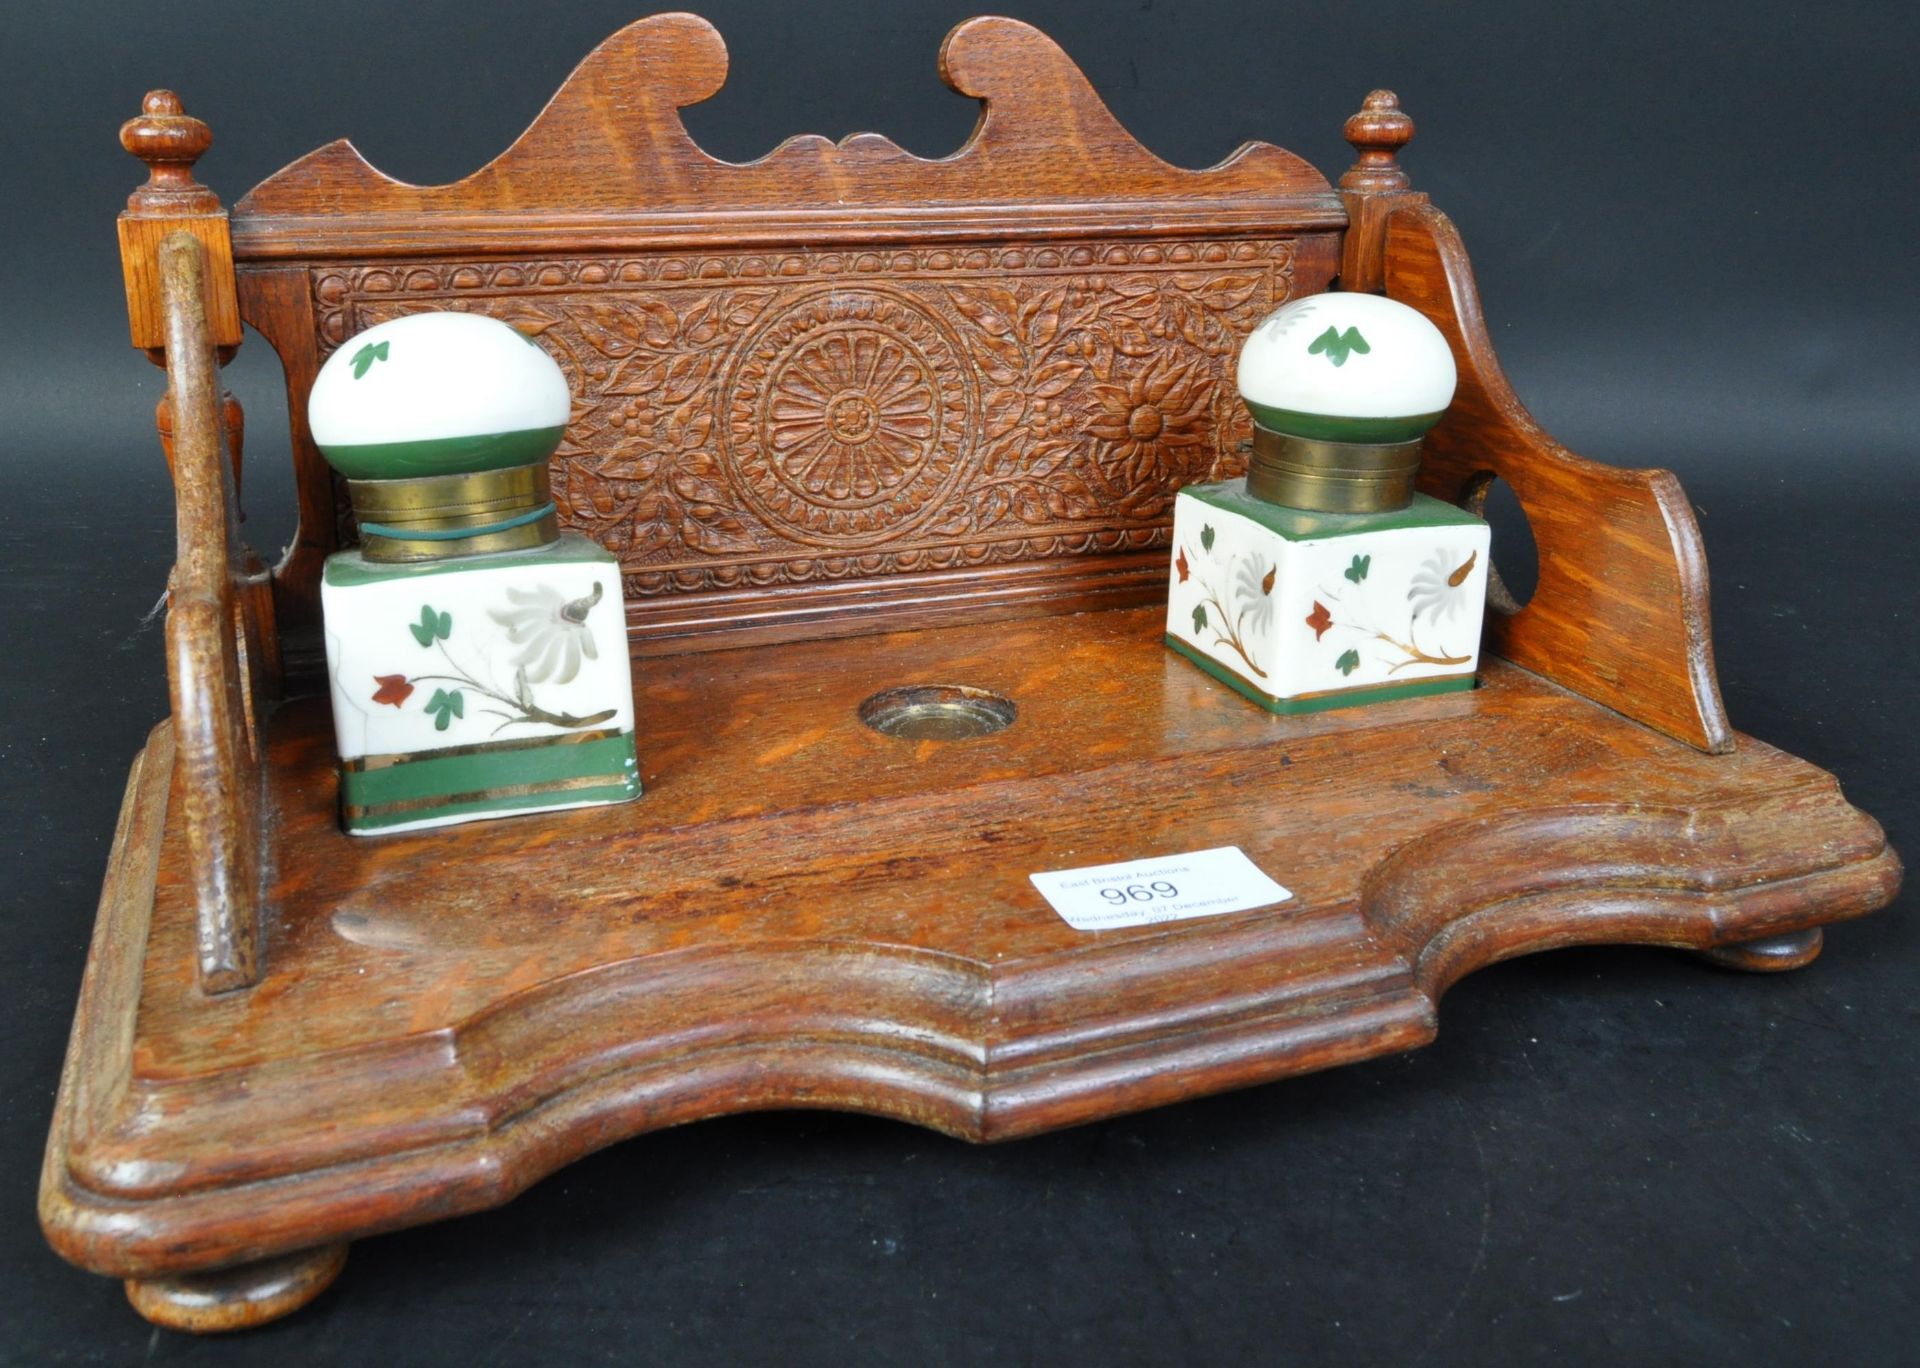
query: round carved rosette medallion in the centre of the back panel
[{"left": 720, "top": 290, "right": 979, "bottom": 548}]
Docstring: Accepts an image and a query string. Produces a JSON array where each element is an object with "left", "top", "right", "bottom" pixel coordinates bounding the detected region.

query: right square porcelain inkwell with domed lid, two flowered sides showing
[{"left": 1167, "top": 294, "right": 1488, "bottom": 713}]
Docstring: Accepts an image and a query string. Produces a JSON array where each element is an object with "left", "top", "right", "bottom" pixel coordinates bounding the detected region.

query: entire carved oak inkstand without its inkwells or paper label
[{"left": 42, "top": 15, "right": 1901, "bottom": 1328}]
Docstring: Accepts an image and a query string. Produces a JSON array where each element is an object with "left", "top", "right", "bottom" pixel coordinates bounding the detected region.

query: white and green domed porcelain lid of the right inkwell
[{"left": 1238, "top": 294, "right": 1455, "bottom": 442}]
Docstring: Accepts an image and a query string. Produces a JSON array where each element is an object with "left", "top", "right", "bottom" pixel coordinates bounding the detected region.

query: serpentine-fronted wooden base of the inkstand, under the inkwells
[{"left": 42, "top": 609, "right": 1901, "bottom": 1328}]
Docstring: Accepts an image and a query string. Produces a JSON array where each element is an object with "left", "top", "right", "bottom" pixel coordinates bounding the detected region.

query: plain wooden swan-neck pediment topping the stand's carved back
[{"left": 234, "top": 13, "right": 1342, "bottom": 251}]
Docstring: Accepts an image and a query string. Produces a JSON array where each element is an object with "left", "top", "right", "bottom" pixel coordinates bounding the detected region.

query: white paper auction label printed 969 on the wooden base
[{"left": 1027, "top": 845, "right": 1292, "bottom": 932}]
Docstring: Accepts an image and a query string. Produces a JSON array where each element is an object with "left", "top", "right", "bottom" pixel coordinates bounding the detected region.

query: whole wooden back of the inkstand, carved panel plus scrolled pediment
[{"left": 232, "top": 15, "right": 1346, "bottom": 651}]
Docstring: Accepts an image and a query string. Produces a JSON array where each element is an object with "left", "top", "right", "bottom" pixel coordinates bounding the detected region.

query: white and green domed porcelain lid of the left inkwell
[{"left": 307, "top": 313, "right": 572, "bottom": 480}]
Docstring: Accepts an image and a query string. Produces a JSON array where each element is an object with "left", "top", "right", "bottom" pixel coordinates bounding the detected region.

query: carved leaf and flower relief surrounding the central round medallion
[{"left": 313, "top": 238, "right": 1294, "bottom": 596}]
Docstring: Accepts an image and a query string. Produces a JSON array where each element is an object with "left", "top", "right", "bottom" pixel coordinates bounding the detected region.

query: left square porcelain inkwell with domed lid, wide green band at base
[{"left": 309, "top": 313, "right": 639, "bottom": 834}]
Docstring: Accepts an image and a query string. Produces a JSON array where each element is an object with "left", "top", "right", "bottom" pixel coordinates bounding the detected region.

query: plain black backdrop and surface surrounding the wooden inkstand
[{"left": 0, "top": 0, "right": 1920, "bottom": 1364}]
